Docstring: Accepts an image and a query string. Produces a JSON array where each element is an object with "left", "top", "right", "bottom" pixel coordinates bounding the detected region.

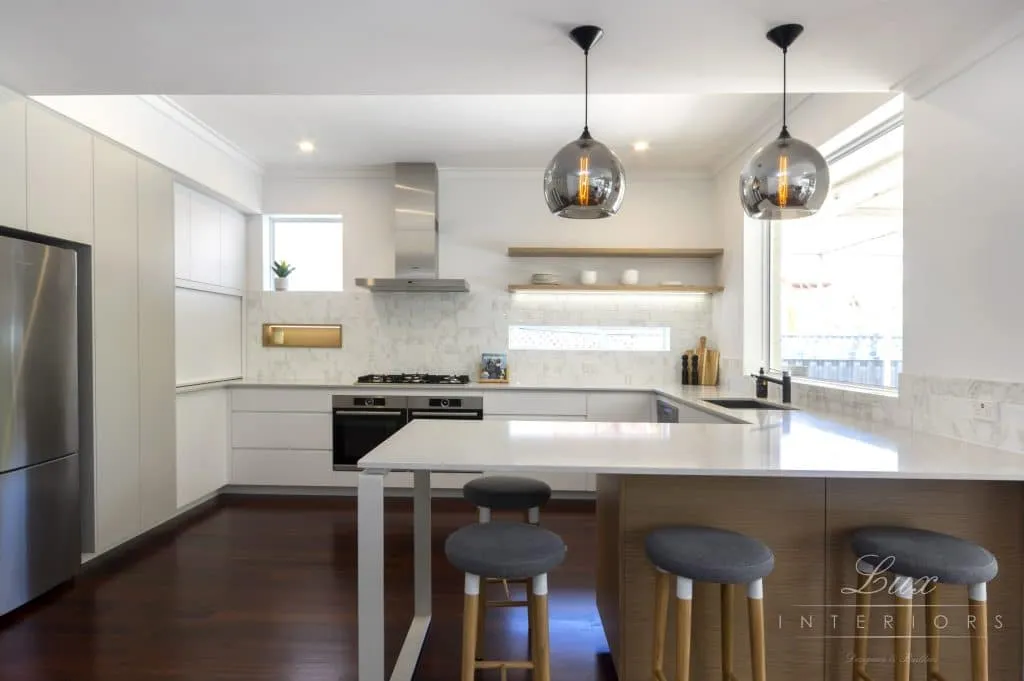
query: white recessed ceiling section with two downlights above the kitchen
[{"left": 174, "top": 94, "right": 781, "bottom": 173}]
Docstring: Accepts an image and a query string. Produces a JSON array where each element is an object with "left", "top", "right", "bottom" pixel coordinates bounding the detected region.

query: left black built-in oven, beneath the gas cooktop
[{"left": 331, "top": 395, "right": 409, "bottom": 470}]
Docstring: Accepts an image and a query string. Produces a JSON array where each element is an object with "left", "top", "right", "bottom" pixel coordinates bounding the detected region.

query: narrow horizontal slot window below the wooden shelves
[{"left": 509, "top": 326, "right": 672, "bottom": 352}]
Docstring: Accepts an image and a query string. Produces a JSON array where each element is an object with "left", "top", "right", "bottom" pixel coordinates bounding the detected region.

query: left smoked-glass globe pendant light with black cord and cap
[{"left": 544, "top": 26, "right": 626, "bottom": 219}]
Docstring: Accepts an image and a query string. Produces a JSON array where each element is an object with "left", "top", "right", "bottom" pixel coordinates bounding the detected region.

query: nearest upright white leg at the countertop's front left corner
[{"left": 356, "top": 470, "right": 387, "bottom": 681}]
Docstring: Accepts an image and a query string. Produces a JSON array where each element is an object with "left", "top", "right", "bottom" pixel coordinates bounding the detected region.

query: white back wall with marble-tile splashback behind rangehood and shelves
[{"left": 246, "top": 169, "right": 720, "bottom": 384}]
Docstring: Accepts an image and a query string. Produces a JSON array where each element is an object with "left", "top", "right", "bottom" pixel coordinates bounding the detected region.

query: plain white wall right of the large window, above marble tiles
[{"left": 903, "top": 31, "right": 1024, "bottom": 382}]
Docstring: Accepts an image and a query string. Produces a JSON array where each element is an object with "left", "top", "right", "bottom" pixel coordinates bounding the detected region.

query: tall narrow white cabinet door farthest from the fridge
[{"left": 137, "top": 159, "right": 177, "bottom": 530}]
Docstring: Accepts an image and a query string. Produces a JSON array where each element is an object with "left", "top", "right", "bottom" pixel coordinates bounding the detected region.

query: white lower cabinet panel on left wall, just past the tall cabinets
[{"left": 175, "top": 388, "right": 228, "bottom": 508}]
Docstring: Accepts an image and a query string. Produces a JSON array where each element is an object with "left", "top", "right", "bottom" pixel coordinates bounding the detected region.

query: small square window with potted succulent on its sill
[{"left": 263, "top": 215, "right": 344, "bottom": 291}]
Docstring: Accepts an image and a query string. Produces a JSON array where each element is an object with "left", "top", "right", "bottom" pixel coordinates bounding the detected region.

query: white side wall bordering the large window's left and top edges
[{"left": 714, "top": 93, "right": 894, "bottom": 378}]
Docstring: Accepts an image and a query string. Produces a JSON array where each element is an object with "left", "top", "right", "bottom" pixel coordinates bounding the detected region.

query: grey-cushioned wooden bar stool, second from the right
[{"left": 646, "top": 526, "right": 775, "bottom": 681}]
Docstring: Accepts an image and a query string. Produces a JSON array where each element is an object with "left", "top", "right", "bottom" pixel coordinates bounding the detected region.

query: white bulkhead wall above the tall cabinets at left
[{"left": 33, "top": 95, "right": 262, "bottom": 213}]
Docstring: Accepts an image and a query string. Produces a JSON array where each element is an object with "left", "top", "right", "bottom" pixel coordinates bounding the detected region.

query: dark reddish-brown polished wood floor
[{"left": 0, "top": 498, "right": 614, "bottom": 681}]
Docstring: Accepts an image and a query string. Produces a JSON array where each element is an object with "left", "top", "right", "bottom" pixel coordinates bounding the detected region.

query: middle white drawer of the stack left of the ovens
[{"left": 231, "top": 412, "right": 333, "bottom": 451}]
